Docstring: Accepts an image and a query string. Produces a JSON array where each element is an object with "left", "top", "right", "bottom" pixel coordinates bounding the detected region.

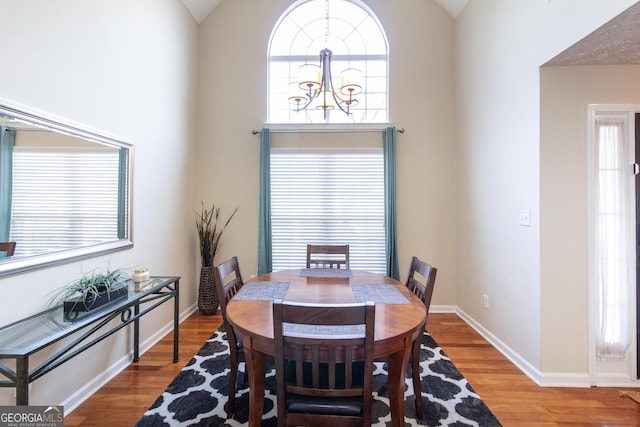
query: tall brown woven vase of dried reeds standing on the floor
[{"left": 194, "top": 202, "right": 238, "bottom": 315}]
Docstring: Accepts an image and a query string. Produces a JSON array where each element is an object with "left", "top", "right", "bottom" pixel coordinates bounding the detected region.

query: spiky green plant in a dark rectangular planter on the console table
[{"left": 52, "top": 269, "right": 130, "bottom": 320}]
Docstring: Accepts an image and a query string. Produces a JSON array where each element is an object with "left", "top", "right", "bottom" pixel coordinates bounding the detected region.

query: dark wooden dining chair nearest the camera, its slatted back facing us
[{"left": 273, "top": 300, "right": 375, "bottom": 427}]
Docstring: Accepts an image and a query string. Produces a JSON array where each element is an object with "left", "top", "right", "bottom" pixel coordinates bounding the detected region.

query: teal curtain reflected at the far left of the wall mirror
[{"left": 0, "top": 126, "right": 16, "bottom": 242}]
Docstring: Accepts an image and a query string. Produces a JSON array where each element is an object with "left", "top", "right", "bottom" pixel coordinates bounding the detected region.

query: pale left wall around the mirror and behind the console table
[{"left": 0, "top": 0, "right": 199, "bottom": 411}]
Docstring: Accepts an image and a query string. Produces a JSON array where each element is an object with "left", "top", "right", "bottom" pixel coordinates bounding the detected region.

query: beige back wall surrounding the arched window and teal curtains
[{"left": 197, "top": 0, "right": 457, "bottom": 306}]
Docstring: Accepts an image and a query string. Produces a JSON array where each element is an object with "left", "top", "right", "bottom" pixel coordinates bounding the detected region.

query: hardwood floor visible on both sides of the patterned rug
[{"left": 65, "top": 313, "right": 640, "bottom": 427}]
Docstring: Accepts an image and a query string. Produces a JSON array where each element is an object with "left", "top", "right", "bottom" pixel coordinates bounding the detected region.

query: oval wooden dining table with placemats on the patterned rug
[{"left": 227, "top": 269, "right": 426, "bottom": 427}]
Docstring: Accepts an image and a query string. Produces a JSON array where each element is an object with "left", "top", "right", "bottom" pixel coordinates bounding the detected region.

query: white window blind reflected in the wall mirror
[{"left": 10, "top": 146, "right": 119, "bottom": 255}]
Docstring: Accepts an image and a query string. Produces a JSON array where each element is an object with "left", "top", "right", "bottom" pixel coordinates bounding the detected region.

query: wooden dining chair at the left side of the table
[{"left": 213, "top": 256, "right": 246, "bottom": 418}]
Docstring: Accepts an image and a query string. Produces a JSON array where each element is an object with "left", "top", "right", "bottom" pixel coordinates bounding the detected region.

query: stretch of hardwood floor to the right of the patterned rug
[{"left": 427, "top": 314, "right": 640, "bottom": 427}]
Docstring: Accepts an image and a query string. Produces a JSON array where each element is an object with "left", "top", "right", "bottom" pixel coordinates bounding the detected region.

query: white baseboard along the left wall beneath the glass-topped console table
[{"left": 61, "top": 304, "right": 198, "bottom": 415}]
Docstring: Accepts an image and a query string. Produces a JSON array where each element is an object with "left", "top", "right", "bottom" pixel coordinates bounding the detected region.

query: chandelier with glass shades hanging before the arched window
[{"left": 289, "top": 0, "right": 362, "bottom": 119}]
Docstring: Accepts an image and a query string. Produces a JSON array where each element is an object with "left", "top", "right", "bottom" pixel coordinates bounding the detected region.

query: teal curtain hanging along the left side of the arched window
[{"left": 258, "top": 128, "right": 273, "bottom": 275}]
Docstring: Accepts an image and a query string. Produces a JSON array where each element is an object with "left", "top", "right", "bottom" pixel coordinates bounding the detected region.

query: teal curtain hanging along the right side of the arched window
[{"left": 383, "top": 126, "right": 400, "bottom": 280}]
